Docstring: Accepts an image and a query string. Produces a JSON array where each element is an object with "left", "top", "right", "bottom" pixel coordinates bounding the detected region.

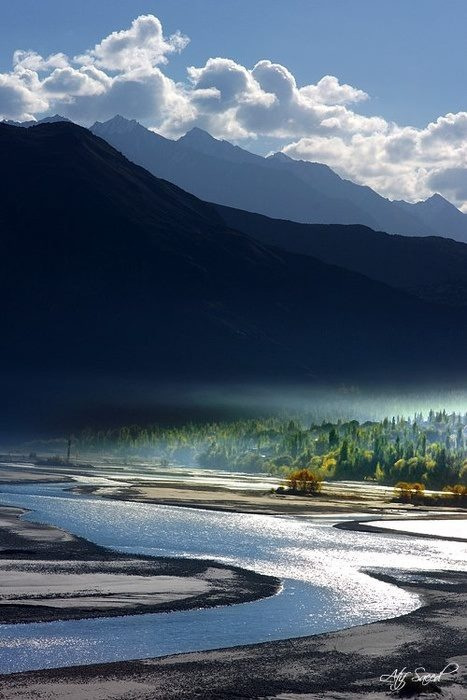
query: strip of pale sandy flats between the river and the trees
[{"left": 4, "top": 462, "right": 467, "bottom": 518}]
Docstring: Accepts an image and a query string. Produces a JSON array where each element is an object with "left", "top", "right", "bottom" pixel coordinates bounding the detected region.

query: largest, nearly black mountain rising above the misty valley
[{"left": 0, "top": 123, "right": 467, "bottom": 432}]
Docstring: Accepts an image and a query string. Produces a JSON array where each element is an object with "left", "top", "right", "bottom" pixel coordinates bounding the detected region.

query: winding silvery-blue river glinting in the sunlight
[{"left": 0, "top": 484, "right": 466, "bottom": 673}]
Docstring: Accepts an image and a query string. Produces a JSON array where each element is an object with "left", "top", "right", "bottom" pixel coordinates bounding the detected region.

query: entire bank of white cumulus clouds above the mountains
[{"left": 0, "top": 15, "right": 467, "bottom": 211}]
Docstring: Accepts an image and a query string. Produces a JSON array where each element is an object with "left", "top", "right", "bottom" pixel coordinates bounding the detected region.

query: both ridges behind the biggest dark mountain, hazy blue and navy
[{"left": 88, "top": 117, "right": 467, "bottom": 305}]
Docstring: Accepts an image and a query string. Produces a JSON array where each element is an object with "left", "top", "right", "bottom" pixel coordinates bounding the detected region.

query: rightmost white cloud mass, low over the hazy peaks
[{"left": 282, "top": 112, "right": 467, "bottom": 209}]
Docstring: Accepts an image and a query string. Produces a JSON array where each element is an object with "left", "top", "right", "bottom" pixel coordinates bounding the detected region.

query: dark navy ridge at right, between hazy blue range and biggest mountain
[{"left": 216, "top": 205, "right": 467, "bottom": 306}]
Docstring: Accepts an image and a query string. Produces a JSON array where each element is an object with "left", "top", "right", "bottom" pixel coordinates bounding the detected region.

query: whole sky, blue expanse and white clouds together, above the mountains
[{"left": 0, "top": 0, "right": 467, "bottom": 212}]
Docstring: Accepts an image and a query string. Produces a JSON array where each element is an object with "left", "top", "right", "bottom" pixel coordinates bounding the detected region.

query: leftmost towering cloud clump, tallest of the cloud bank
[{"left": 0, "top": 15, "right": 194, "bottom": 128}]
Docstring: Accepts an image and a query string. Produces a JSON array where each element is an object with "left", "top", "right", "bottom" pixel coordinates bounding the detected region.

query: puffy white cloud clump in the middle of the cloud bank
[{"left": 188, "top": 58, "right": 386, "bottom": 138}]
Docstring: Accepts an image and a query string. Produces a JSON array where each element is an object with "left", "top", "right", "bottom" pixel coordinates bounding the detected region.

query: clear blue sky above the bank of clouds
[{"left": 0, "top": 0, "right": 467, "bottom": 126}]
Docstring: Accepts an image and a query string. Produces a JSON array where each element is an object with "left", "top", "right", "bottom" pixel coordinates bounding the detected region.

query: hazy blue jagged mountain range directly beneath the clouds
[{"left": 91, "top": 117, "right": 467, "bottom": 242}]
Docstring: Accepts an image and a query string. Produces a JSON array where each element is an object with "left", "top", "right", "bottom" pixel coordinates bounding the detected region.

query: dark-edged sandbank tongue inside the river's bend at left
[{"left": 0, "top": 506, "right": 280, "bottom": 624}]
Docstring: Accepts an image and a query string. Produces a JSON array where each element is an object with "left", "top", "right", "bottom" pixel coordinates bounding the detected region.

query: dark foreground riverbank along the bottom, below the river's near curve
[{"left": 0, "top": 571, "right": 467, "bottom": 700}]
